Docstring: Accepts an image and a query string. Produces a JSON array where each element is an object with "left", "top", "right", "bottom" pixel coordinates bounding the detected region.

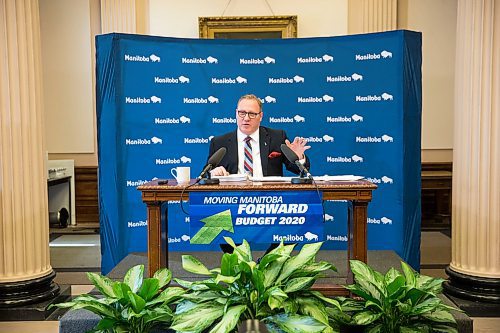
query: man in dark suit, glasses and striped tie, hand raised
[{"left": 208, "top": 95, "right": 310, "bottom": 177}]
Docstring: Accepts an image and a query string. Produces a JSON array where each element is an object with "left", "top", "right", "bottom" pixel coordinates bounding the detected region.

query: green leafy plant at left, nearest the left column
[{"left": 50, "top": 265, "right": 185, "bottom": 333}]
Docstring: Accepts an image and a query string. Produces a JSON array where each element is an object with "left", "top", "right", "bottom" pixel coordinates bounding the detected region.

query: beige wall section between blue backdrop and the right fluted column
[{"left": 405, "top": 0, "right": 457, "bottom": 162}]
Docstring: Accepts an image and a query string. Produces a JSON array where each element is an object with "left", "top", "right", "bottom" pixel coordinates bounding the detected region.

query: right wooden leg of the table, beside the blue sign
[{"left": 347, "top": 201, "right": 368, "bottom": 284}]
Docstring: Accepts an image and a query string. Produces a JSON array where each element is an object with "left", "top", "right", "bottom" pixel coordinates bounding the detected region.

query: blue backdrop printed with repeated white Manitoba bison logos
[{"left": 96, "top": 31, "right": 422, "bottom": 273}]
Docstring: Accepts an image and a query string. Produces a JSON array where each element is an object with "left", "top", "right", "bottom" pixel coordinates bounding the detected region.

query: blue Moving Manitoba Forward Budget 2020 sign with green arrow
[{"left": 189, "top": 191, "right": 323, "bottom": 244}]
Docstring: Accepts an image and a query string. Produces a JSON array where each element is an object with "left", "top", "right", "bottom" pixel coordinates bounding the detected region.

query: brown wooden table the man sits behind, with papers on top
[{"left": 137, "top": 180, "right": 377, "bottom": 280}]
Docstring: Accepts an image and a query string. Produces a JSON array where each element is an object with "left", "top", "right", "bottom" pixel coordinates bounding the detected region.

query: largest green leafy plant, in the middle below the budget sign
[{"left": 171, "top": 237, "right": 338, "bottom": 333}]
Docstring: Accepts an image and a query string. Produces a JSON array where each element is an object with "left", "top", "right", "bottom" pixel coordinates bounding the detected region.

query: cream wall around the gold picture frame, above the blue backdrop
[{"left": 149, "top": 0, "right": 347, "bottom": 38}]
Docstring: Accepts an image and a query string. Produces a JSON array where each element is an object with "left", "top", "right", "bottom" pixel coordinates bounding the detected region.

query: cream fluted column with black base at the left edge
[{"left": 0, "top": 0, "right": 59, "bottom": 307}]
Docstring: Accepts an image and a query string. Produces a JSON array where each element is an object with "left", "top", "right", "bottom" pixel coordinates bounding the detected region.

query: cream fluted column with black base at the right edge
[{"left": 445, "top": 0, "right": 500, "bottom": 303}]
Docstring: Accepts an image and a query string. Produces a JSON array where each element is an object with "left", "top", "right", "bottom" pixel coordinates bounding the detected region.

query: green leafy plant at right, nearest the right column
[{"left": 327, "top": 260, "right": 457, "bottom": 333}]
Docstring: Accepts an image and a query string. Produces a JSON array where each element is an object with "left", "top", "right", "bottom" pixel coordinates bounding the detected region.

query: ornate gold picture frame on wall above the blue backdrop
[{"left": 198, "top": 15, "right": 297, "bottom": 39}]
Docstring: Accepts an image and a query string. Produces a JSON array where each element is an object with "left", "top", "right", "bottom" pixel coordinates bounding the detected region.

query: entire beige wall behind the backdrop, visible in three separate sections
[{"left": 40, "top": 0, "right": 456, "bottom": 166}]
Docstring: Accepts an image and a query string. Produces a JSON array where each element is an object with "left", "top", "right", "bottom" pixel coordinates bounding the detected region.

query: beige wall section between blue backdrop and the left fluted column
[{"left": 39, "top": 0, "right": 95, "bottom": 158}]
